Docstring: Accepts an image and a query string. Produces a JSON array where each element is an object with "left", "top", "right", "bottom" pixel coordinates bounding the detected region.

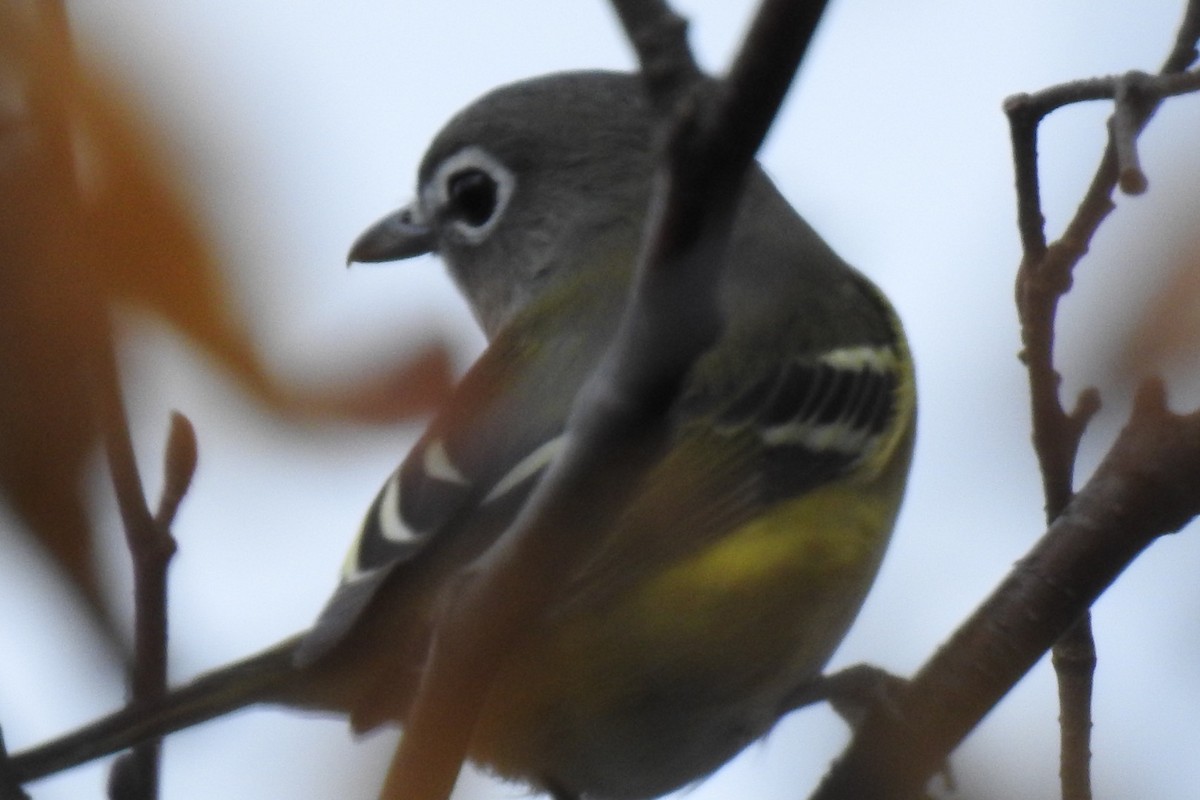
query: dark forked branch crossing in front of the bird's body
[{"left": 383, "top": 0, "right": 823, "bottom": 800}]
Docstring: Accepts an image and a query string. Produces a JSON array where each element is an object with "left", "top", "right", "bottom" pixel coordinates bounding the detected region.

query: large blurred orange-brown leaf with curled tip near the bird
[{"left": 0, "top": 0, "right": 451, "bottom": 633}]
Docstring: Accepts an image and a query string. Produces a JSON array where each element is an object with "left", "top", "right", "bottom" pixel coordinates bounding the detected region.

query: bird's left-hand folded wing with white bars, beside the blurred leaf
[{"left": 296, "top": 278, "right": 620, "bottom": 664}]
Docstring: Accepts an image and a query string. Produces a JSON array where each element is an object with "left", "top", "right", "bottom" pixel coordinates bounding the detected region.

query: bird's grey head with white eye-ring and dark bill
[{"left": 349, "top": 72, "right": 654, "bottom": 337}]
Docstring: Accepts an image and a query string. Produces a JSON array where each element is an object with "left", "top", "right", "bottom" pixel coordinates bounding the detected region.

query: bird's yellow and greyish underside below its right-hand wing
[{"left": 460, "top": 262, "right": 916, "bottom": 798}]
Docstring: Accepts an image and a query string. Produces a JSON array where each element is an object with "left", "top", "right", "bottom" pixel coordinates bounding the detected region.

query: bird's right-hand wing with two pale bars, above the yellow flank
[{"left": 564, "top": 345, "right": 898, "bottom": 610}]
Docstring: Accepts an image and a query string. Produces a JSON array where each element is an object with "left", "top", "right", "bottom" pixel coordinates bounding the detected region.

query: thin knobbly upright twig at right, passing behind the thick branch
[{"left": 1004, "top": 7, "right": 1200, "bottom": 800}]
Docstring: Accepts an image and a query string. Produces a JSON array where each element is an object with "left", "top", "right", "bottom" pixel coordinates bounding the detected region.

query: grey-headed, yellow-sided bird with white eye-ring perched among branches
[{"left": 12, "top": 71, "right": 917, "bottom": 800}]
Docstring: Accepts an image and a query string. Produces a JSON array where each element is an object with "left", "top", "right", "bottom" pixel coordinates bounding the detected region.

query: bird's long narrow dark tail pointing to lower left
[{"left": 8, "top": 636, "right": 302, "bottom": 783}]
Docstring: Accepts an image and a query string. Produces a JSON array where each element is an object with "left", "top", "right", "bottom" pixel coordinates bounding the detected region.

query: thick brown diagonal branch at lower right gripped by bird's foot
[{"left": 814, "top": 383, "right": 1200, "bottom": 800}]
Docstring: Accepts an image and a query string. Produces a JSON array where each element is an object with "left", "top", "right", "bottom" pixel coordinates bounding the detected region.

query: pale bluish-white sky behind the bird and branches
[{"left": 0, "top": 0, "right": 1200, "bottom": 800}]
